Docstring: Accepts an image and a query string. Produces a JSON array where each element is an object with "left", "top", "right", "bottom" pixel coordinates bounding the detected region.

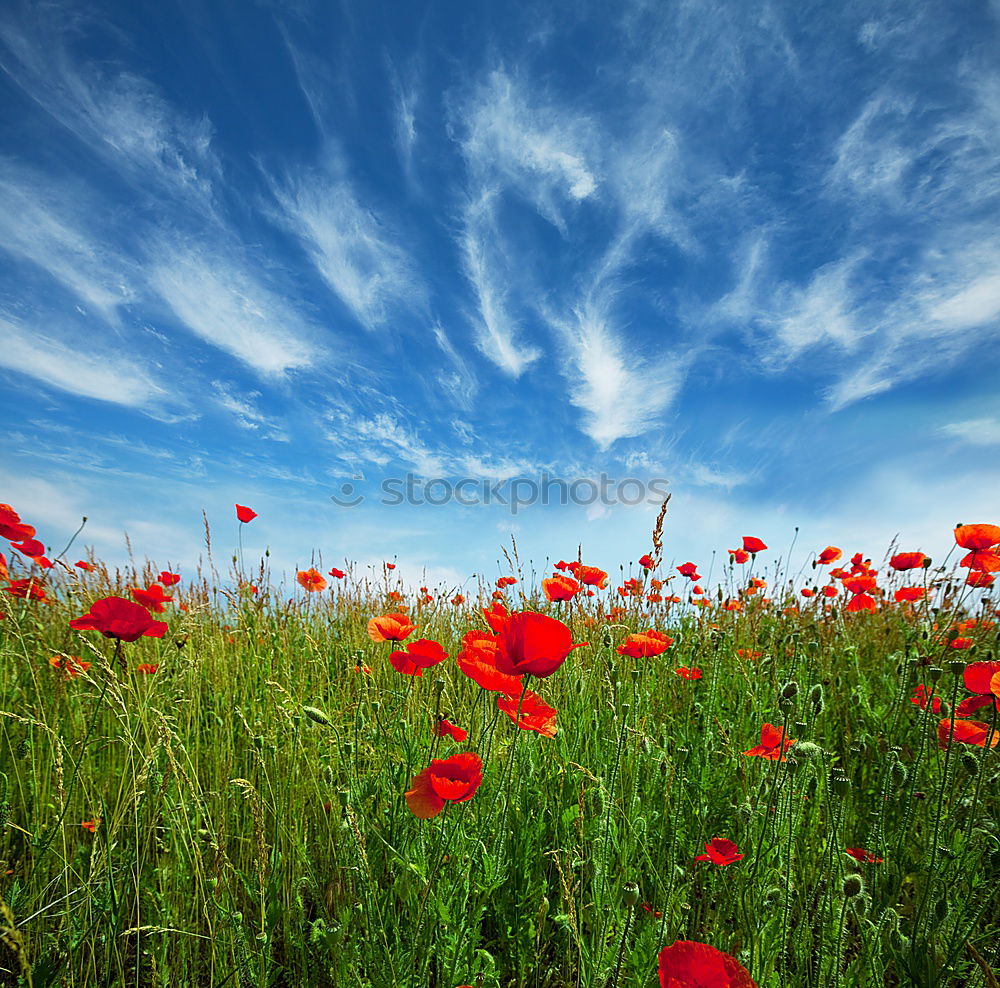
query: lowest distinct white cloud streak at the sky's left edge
[{"left": 0, "top": 316, "right": 167, "bottom": 408}]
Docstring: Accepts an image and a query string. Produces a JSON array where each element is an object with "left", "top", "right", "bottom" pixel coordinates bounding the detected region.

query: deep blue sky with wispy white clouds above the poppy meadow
[{"left": 0, "top": 0, "right": 1000, "bottom": 585}]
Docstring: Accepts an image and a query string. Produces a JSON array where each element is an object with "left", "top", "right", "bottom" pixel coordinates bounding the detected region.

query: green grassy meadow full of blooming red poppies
[{"left": 0, "top": 505, "right": 1000, "bottom": 988}]
